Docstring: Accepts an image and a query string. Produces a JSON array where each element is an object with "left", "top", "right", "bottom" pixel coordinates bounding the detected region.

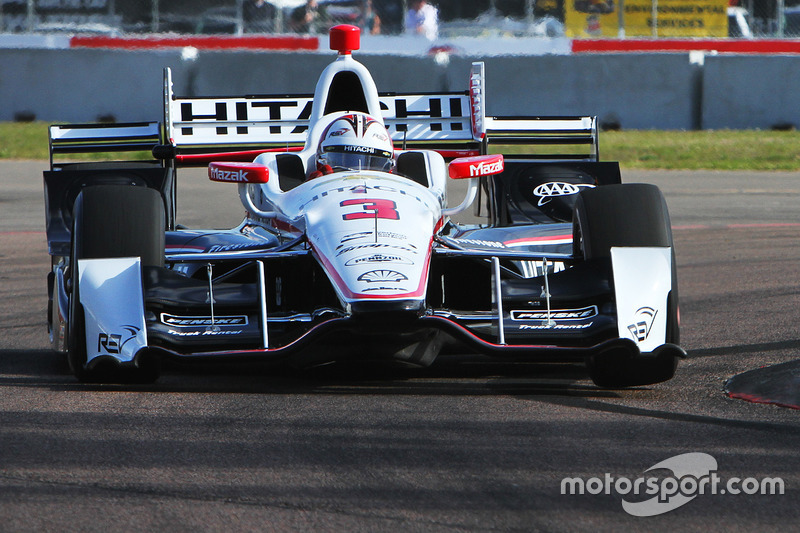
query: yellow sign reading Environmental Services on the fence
[{"left": 564, "top": 0, "right": 728, "bottom": 37}]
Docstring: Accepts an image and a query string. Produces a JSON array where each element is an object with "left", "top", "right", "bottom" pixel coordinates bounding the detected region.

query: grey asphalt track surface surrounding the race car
[{"left": 0, "top": 162, "right": 800, "bottom": 532}]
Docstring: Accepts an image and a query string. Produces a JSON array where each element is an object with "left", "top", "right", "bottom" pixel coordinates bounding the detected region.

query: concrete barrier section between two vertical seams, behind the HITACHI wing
[{"left": 186, "top": 52, "right": 699, "bottom": 129}]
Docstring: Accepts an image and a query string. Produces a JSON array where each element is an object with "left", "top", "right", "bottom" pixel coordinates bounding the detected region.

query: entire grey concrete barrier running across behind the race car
[{"left": 0, "top": 49, "right": 800, "bottom": 129}]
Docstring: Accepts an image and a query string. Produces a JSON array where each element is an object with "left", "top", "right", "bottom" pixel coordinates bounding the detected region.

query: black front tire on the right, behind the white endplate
[{"left": 573, "top": 183, "right": 680, "bottom": 387}]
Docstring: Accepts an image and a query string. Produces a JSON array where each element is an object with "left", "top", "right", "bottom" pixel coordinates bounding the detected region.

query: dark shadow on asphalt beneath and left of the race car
[{"left": 0, "top": 350, "right": 619, "bottom": 398}]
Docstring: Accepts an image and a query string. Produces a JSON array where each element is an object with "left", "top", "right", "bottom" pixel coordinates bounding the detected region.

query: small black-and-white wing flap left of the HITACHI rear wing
[{"left": 49, "top": 122, "right": 162, "bottom": 169}]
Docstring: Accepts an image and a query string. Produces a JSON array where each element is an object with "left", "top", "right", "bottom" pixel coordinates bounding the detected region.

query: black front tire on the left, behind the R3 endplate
[{"left": 67, "top": 185, "right": 165, "bottom": 383}]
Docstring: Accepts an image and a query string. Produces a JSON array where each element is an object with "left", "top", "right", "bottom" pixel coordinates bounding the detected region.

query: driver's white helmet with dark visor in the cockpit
[{"left": 317, "top": 113, "right": 394, "bottom": 172}]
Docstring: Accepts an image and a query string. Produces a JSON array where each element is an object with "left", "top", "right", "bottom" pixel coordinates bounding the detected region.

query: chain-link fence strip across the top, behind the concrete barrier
[{"left": 0, "top": 0, "right": 800, "bottom": 38}]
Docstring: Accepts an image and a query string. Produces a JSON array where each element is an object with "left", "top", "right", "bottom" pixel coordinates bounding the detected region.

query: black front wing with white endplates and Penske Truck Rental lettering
[{"left": 64, "top": 241, "right": 680, "bottom": 365}]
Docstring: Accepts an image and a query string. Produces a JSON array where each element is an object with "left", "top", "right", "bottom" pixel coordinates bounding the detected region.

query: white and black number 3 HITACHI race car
[{"left": 44, "top": 26, "right": 686, "bottom": 387}]
